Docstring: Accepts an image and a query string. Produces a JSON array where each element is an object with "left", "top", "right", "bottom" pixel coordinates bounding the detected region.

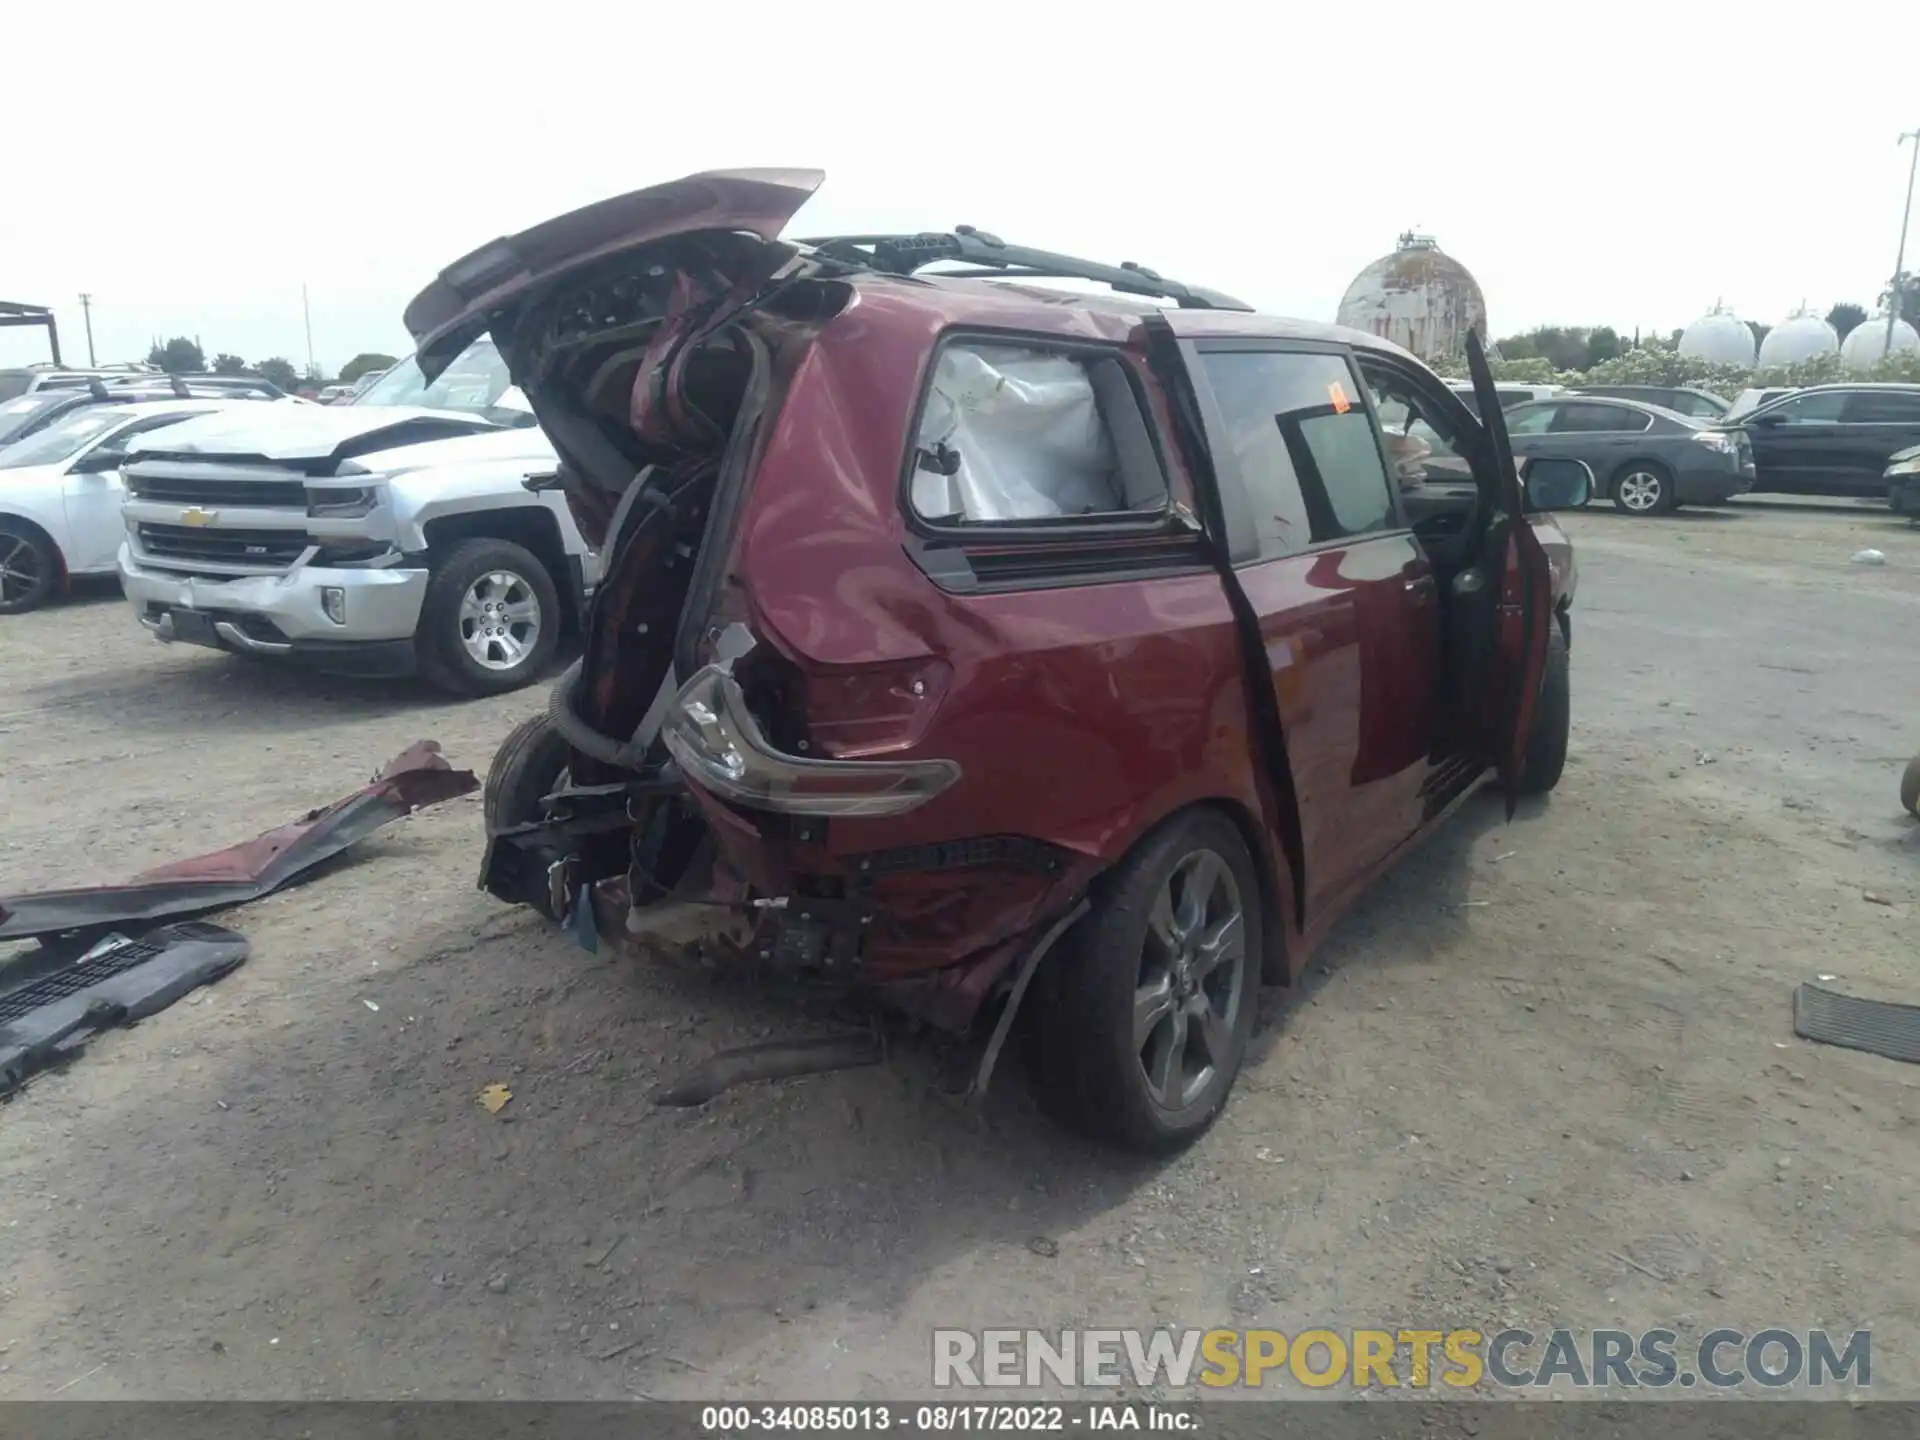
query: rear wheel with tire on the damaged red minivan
[{"left": 1023, "top": 808, "right": 1265, "bottom": 1152}]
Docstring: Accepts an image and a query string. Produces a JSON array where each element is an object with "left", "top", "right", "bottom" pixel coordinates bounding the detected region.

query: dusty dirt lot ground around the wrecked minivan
[{"left": 0, "top": 505, "right": 1920, "bottom": 1398}]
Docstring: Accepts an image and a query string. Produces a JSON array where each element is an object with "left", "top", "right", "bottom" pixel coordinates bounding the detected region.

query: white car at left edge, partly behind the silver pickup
[{"left": 0, "top": 397, "right": 251, "bottom": 614}]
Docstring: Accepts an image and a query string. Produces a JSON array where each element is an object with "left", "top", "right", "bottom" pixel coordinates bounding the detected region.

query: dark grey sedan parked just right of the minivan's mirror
[{"left": 1507, "top": 396, "right": 1753, "bottom": 516}]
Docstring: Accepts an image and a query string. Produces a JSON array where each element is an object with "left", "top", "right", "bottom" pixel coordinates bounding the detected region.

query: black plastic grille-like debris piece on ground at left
[{"left": 0, "top": 920, "right": 248, "bottom": 1094}]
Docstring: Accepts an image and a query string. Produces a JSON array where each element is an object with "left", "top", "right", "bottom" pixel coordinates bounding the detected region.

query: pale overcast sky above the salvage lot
[{"left": 0, "top": 0, "right": 1920, "bottom": 371}]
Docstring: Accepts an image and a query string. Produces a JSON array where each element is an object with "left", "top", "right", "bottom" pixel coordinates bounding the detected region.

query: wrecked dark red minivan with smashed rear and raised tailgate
[{"left": 407, "top": 169, "right": 1592, "bottom": 1148}]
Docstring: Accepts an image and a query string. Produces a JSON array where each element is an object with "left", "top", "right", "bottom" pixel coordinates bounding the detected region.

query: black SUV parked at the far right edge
[{"left": 1740, "top": 384, "right": 1920, "bottom": 497}]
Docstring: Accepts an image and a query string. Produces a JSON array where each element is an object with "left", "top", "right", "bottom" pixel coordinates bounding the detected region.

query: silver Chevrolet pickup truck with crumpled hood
[{"left": 119, "top": 340, "right": 599, "bottom": 695}]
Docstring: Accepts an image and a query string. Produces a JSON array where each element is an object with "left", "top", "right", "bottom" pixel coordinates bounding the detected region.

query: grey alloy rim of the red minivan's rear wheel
[{"left": 1133, "top": 851, "right": 1248, "bottom": 1110}]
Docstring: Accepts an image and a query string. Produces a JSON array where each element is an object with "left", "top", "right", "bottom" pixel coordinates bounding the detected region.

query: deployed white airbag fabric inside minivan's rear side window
[{"left": 914, "top": 346, "right": 1125, "bottom": 520}]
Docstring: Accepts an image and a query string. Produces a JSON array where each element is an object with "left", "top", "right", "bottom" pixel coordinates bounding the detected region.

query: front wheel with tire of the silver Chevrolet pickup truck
[{"left": 415, "top": 540, "right": 561, "bottom": 695}]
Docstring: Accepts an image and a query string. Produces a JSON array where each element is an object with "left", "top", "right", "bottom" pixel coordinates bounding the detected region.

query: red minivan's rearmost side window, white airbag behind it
[{"left": 908, "top": 340, "right": 1167, "bottom": 526}]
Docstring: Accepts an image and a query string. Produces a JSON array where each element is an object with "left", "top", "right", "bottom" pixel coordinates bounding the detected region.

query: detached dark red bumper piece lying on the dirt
[{"left": 0, "top": 739, "right": 480, "bottom": 941}]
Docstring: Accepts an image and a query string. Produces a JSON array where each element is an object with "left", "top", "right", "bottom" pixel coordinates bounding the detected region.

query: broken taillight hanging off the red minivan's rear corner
[{"left": 660, "top": 664, "right": 960, "bottom": 816}]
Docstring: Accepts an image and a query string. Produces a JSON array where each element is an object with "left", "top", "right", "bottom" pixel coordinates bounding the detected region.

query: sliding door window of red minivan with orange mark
[{"left": 1200, "top": 349, "right": 1398, "bottom": 557}]
